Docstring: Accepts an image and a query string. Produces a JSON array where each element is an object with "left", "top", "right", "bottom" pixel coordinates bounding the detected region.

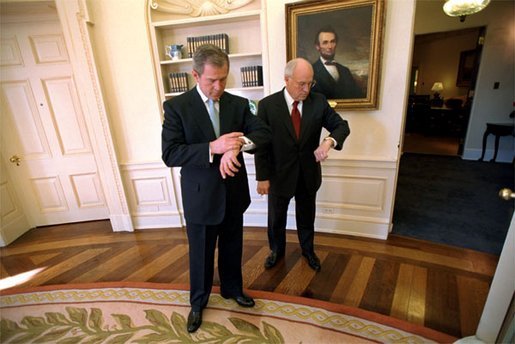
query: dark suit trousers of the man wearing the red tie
[{"left": 268, "top": 169, "right": 316, "bottom": 255}]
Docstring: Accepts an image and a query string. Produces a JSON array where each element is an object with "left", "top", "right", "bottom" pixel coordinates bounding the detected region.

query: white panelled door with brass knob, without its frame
[{"left": 0, "top": 13, "right": 109, "bottom": 226}]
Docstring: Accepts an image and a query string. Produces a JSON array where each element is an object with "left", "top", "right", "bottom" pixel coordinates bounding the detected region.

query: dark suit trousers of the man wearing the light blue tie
[{"left": 187, "top": 214, "right": 243, "bottom": 311}]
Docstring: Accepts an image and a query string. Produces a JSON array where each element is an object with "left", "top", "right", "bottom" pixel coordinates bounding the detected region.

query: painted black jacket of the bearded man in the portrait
[{"left": 313, "top": 59, "right": 365, "bottom": 99}]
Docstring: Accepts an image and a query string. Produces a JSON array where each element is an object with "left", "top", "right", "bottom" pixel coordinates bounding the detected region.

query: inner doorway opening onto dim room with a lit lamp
[{"left": 403, "top": 27, "right": 486, "bottom": 156}]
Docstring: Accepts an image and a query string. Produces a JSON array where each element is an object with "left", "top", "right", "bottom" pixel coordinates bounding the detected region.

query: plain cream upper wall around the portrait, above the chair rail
[{"left": 267, "top": 0, "right": 414, "bottom": 161}]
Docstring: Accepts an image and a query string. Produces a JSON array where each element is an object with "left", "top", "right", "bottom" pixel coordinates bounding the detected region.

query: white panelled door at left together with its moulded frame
[{"left": 0, "top": 0, "right": 133, "bottom": 246}]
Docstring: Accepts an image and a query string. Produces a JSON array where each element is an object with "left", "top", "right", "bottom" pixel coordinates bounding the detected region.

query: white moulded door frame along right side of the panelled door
[{"left": 54, "top": 0, "right": 134, "bottom": 232}]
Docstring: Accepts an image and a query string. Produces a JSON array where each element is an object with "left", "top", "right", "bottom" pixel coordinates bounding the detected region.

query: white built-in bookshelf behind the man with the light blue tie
[{"left": 148, "top": 0, "right": 268, "bottom": 106}]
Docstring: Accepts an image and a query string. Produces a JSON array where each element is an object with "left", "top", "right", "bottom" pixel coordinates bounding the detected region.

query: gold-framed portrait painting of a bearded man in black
[{"left": 285, "top": 0, "right": 385, "bottom": 110}]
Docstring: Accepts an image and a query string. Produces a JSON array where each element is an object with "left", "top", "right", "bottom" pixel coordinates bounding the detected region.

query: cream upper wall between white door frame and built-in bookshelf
[{"left": 87, "top": 0, "right": 161, "bottom": 164}]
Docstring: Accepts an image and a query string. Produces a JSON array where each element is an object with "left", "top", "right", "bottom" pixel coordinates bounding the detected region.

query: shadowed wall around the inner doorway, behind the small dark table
[{"left": 415, "top": 0, "right": 515, "bottom": 162}]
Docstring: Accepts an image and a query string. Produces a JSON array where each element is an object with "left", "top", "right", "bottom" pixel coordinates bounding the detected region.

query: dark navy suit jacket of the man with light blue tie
[{"left": 162, "top": 87, "right": 270, "bottom": 225}]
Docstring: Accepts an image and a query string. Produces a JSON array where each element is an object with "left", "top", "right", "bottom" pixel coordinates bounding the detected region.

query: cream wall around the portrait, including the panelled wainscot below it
[{"left": 267, "top": 0, "right": 414, "bottom": 238}]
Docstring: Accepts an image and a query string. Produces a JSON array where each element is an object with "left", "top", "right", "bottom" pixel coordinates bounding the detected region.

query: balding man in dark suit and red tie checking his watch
[{"left": 255, "top": 58, "right": 350, "bottom": 271}]
